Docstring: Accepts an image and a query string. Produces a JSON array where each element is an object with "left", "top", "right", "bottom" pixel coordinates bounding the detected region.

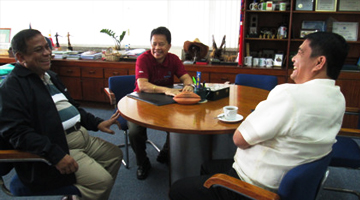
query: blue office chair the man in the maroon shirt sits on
[{"left": 105, "top": 75, "right": 160, "bottom": 168}]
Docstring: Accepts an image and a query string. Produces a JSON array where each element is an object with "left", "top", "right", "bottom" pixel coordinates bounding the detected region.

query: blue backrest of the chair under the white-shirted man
[{"left": 278, "top": 153, "right": 332, "bottom": 200}]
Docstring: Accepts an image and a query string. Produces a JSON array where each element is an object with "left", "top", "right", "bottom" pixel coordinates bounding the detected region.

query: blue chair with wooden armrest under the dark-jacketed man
[{"left": 0, "top": 149, "right": 81, "bottom": 197}]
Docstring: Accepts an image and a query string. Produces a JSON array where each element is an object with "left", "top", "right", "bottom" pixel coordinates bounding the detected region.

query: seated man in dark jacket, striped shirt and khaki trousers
[{"left": 0, "top": 29, "right": 122, "bottom": 199}]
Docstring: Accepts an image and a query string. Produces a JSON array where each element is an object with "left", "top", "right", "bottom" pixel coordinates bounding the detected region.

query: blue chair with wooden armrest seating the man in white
[{"left": 204, "top": 153, "right": 331, "bottom": 200}]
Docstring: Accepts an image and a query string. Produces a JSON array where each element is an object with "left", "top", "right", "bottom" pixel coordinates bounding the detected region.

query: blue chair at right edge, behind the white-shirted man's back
[{"left": 324, "top": 107, "right": 360, "bottom": 200}]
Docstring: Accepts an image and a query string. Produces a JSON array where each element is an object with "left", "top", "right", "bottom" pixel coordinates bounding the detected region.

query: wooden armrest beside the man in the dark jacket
[{"left": 0, "top": 150, "right": 51, "bottom": 165}]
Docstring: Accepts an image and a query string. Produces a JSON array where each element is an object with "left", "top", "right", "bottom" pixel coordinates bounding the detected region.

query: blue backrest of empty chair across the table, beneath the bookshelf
[{"left": 235, "top": 74, "right": 278, "bottom": 91}]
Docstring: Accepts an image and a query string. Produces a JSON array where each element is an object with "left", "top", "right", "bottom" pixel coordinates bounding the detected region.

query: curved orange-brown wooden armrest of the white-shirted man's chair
[{"left": 204, "top": 174, "right": 280, "bottom": 200}]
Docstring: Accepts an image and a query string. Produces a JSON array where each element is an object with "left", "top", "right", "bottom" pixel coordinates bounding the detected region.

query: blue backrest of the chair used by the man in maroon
[{"left": 109, "top": 75, "right": 135, "bottom": 102}]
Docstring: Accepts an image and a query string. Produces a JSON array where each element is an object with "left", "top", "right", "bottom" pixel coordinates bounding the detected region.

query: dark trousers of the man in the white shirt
[{"left": 169, "top": 159, "right": 248, "bottom": 200}]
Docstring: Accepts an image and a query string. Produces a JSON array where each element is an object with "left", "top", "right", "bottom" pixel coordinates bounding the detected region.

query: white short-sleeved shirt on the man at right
[{"left": 233, "top": 79, "right": 345, "bottom": 191}]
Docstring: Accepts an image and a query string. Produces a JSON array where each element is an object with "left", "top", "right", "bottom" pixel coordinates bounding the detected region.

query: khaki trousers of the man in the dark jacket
[{"left": 66, "top": 127, "right": 123, "bottom": 200}]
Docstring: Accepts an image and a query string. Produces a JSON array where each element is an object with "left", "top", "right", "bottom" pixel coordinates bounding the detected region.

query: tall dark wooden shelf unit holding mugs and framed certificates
[{"left": 240, "top": 0, "right": 360, "bottom": 70}]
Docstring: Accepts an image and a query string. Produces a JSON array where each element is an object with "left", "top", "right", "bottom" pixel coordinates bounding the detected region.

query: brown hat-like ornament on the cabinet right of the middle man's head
[{"left": 183, "top": 38, "right": 209, "bottom": 62}]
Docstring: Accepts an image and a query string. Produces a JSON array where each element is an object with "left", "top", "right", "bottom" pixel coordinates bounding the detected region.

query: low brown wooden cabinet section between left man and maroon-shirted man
[{"left": 52, "top": 60, "right": 135, "bottom": 102}]
